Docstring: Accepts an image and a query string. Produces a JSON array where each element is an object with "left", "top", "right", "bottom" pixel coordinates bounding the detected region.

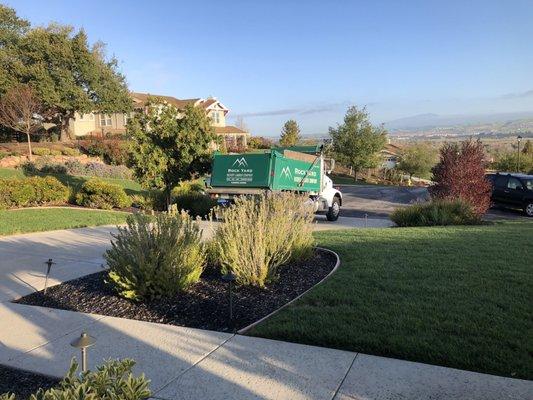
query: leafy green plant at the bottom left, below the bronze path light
[{"left": 0, "top": 359, "right": 151, "bottom": 400}]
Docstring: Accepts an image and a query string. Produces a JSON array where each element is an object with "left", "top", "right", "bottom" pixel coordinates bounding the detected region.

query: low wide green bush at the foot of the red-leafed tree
[{"left": 390, "top": 200, "right": 481, "bottom": 227}]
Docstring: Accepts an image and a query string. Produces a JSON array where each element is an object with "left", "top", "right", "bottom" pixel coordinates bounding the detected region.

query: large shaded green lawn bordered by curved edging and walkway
[{"left": 250, "top": 222, "right": 533, "bottom": 379}]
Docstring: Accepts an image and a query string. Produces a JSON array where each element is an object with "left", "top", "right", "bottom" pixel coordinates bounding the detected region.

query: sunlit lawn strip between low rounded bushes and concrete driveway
[{"left": 0, "top": 208, "right": 128, "bottom": 236}]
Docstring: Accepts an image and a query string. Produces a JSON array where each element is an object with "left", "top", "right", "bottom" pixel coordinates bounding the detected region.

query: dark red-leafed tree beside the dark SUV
[{"left": 429, "top": 140, "right": 491, "bottom": 215}]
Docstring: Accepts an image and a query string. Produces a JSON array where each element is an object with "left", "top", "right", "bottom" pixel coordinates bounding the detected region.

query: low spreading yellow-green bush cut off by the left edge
[{"left": 0, "top": 176, "right": 70, "bottom": 209}]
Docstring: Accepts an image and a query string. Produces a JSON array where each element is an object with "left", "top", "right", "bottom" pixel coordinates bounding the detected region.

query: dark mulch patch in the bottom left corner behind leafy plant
[{"left": 0, "top": 364, "right": 60, "bottom": 400}]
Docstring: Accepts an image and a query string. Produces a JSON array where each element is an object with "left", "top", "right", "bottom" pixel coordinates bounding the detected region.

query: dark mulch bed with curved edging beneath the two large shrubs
[{"left": 16, "top": 249, "right": 336, "bottom": 332}]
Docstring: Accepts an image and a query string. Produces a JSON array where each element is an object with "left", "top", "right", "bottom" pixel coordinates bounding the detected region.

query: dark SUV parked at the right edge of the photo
[{"left": 487, "top": 172, "right": 533, "bottom": 217}]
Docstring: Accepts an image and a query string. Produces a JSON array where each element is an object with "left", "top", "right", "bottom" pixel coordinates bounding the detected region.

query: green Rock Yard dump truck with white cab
[{"left": 207, "top": 146, "right": 342, "bottom": 221}]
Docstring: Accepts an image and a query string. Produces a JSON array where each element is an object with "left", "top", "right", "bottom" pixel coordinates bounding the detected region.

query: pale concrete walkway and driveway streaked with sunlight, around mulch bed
[{"left": 0, "top": 227, "right": 533, "bottom": 400}]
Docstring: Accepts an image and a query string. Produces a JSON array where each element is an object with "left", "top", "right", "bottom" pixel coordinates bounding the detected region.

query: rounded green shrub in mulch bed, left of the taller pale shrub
[{"left": 104, "top": 213, "right": 206, "bottom": 299}]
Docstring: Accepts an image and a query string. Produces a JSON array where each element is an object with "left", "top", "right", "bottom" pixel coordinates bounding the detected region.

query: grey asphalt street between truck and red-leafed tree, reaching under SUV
[{"left": 339, "top": 185, "right": 529, "bottom": 221}]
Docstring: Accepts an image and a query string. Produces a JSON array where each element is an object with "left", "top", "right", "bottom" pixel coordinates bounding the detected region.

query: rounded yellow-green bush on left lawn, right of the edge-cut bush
[{"left": 76, "top": 178, "right": 131, "bottom": 210}]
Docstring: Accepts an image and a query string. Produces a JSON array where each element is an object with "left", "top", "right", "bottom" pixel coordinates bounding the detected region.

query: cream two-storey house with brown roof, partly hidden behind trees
[{"left": 70, "top": 92, "right": 250, "bottom": 148}]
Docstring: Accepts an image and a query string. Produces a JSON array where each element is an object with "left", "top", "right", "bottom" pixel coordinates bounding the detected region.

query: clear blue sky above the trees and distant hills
[{"left": 7, "top": 0, "right": 533, "bottom": 136}]
